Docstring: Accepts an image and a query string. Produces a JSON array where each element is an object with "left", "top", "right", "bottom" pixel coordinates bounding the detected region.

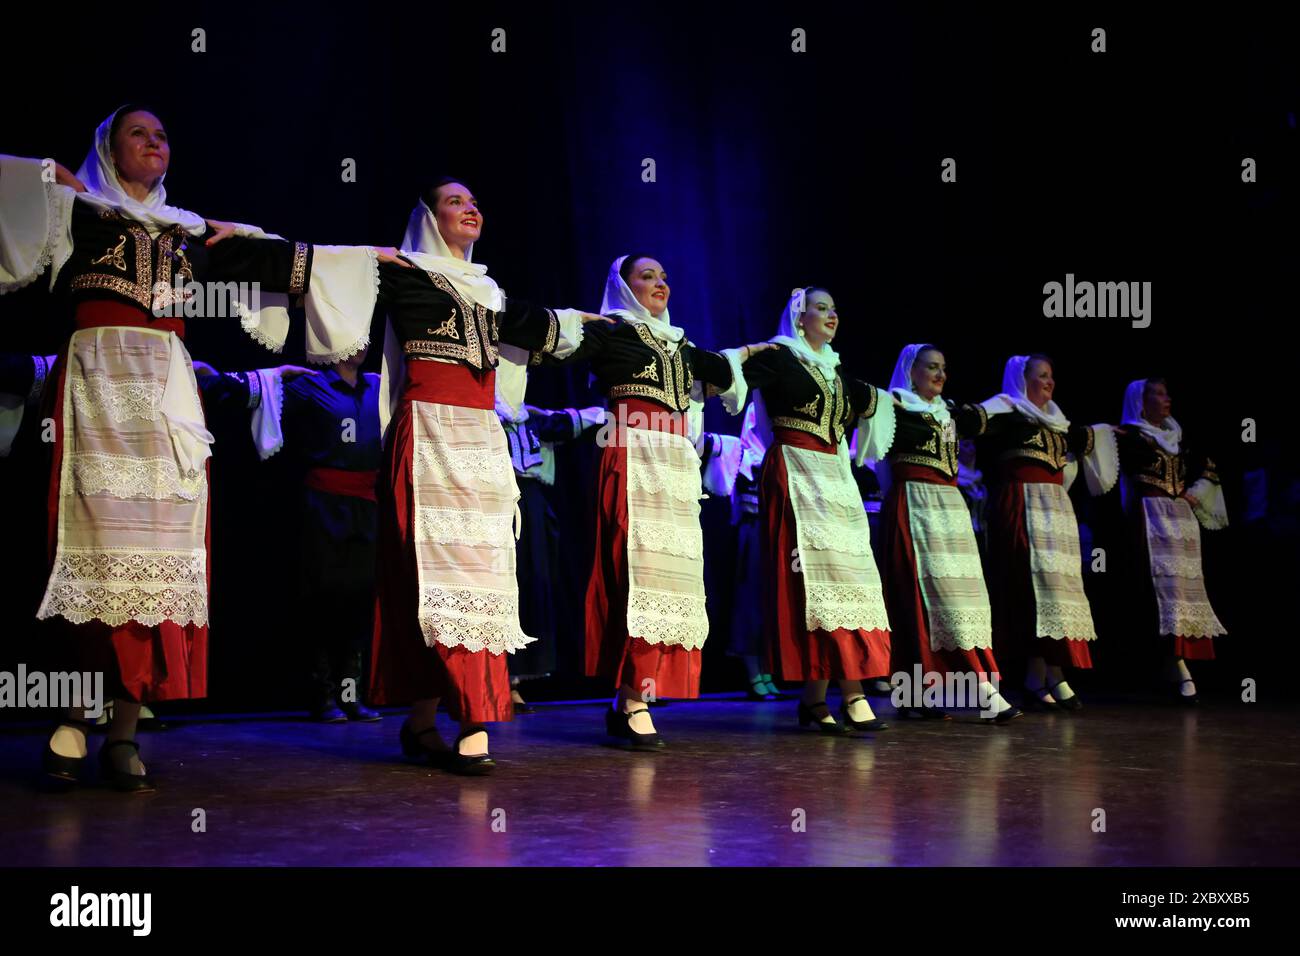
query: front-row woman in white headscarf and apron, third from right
[{"left": 868, "top": 345, "right": 1022, "bottom": 723}]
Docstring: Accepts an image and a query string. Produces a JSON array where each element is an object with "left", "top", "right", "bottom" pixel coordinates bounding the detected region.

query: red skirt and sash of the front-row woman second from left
[{"left": 369, "top": 362, "right": 515, "bottom": 723}]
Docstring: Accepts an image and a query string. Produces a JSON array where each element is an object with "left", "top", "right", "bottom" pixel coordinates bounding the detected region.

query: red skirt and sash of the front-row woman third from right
[{"left": 880, "top": 464, "right": 1001, "bottom": 679}]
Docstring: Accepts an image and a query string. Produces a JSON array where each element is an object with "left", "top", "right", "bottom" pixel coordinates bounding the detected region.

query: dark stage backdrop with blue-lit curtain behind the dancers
[{"left": 0, "top": 3, "right": 1300, "bottom": 708}]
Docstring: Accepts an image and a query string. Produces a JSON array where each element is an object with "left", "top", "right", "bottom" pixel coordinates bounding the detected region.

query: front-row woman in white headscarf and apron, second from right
[{"left": 979, "top": 355, "right": 1119, "bottom": 711}]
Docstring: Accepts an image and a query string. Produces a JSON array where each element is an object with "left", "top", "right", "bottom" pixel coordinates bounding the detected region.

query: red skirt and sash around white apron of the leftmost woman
[{"left": 42, "top": 300, "right": 212, "bottom": 702}]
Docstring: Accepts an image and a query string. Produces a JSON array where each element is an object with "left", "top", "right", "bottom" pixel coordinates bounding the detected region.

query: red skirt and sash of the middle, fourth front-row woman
[{"left": 759, "top": 429, "right": 889, "bottom": 680}]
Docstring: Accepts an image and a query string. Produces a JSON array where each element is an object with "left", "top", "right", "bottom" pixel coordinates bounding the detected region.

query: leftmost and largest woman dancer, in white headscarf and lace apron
[{"left": 0, "top": 105, "right": 395, "bottom": 792}]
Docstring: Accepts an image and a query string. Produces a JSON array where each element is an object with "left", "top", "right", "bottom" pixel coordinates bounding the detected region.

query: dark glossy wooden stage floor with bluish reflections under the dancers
[{"left": 0, "top": 696, "right": 1300, "bottom": 866}]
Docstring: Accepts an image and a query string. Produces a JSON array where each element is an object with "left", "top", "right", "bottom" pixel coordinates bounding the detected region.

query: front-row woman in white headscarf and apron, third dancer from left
[{"left": 546, "top": 255, "right": 767, "bottom": 750}]
